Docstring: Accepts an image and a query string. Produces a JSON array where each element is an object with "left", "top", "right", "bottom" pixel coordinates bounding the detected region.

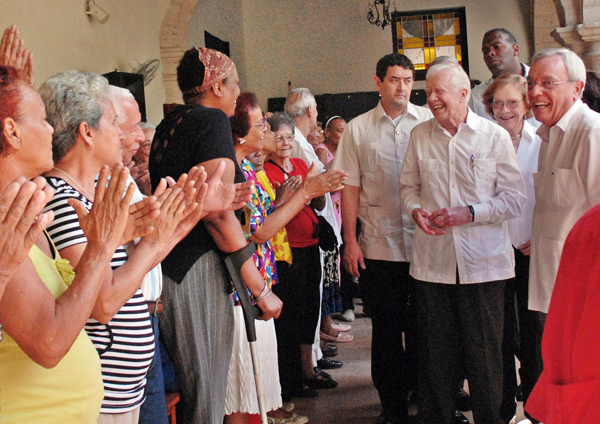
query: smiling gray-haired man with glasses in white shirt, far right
[{"left": 527, "top": 48, "right": 600, "bottom": 418}]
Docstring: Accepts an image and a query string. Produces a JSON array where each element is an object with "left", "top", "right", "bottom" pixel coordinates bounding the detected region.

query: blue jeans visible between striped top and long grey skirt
[{"left": 139, "top": 316, "right": 169, "bottom": 424}]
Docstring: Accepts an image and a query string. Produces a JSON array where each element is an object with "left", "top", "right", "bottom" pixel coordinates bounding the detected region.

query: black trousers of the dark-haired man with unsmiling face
[{"left": 360, "top": 259, "right": 416, "bottom": 422}]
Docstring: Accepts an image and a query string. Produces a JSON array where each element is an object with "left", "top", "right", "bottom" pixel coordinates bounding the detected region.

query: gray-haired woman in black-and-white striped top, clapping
[{"left": 40, "top": 71, "right": 202, "bottom": 423}]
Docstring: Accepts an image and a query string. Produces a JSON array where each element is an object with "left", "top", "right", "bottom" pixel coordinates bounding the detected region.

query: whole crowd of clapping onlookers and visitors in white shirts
[{"left": 0, "top": 20, "right": 600, "bottom": 424}]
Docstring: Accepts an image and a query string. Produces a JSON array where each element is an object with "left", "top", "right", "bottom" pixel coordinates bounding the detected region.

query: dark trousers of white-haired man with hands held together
[{"left": 416, "top": 281, "right": 504, "bottom": 424}]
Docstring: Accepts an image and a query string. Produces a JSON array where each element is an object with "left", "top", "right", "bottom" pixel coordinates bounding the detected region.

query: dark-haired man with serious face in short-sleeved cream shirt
[{"left": 333, "top": 53, "right": 432, "bottom": 424}]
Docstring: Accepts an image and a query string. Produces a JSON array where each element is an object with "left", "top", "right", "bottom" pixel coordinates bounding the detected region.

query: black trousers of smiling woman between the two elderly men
[{"left": 501, "top": 249, "right": 543, "bottom": 423}]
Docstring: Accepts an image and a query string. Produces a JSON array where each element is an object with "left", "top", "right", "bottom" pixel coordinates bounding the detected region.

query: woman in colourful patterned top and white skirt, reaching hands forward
[{"left": 225, "top": 100, "right": 345, "bottom": 424}]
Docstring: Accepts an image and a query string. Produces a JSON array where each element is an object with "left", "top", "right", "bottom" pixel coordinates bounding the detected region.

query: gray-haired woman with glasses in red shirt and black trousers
[{"left": 264, "top": 113, "right": 346, "bottom": 401}]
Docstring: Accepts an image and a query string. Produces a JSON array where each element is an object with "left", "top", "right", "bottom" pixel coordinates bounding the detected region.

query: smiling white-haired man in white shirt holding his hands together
[{"left": 400, "top": 63, "right": 526, "bottom": 424}]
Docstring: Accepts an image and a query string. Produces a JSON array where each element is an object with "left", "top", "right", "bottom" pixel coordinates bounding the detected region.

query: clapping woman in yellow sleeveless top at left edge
[{"left": 0, "top": 66, "right": 139, "bottom": 424}]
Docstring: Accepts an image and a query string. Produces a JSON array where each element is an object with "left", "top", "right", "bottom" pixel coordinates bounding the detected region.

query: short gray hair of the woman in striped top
[{"left": 39, "top": 71, "right": 110, "bottom": 163}]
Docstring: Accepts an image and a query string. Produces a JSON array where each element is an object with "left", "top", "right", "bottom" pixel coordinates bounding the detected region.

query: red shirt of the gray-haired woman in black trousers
[{"left": 263, "top": 158, "right": 319, "bottom": 247}]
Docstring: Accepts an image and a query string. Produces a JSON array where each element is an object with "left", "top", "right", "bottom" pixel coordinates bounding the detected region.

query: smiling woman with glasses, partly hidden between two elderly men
[{"left": 482, "top": 74, "right": 541, "bottom": 420}]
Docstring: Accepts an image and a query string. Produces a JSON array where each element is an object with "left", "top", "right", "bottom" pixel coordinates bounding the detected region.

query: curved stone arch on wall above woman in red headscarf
[{"left": 159, "top": 0, "right": 198, "bottom": 104}]
